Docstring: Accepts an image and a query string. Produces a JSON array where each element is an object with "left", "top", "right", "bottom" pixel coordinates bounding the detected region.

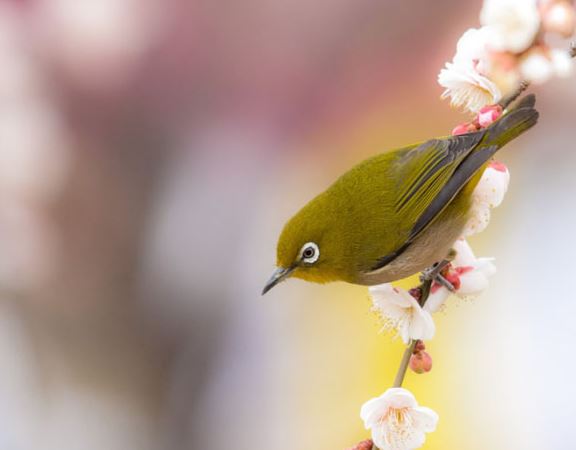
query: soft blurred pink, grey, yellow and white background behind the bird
[{"left": 0, "top": 0, "right": 576, "bottom": 450}]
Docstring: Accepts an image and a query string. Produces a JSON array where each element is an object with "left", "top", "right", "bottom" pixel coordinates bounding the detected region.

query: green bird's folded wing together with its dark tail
[{"left": 371, "top": 95, "right": 538, "bottom": 270}]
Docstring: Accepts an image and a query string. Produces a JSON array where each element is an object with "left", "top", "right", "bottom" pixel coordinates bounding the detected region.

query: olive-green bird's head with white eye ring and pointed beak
[{"left": 262, "top": 202, "right": 343, "bottom": 294}]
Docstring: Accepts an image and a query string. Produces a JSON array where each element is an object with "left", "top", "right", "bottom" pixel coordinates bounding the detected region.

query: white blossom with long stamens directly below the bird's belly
[{"left": 369, "top": 283, "right": 436, "bottom": 344}]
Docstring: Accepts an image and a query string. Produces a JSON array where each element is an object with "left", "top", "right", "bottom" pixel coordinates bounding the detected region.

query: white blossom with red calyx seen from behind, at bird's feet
[{"left": 424, "top": 239, "right": 496, "bottom": 313}]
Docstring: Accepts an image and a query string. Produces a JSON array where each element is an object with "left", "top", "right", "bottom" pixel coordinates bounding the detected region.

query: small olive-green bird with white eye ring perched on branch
[{"left": 262, "top": 95, "right": 538, "bottom": 294}]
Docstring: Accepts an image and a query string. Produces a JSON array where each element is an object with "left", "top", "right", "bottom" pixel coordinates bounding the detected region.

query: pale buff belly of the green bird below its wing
[{"left": 356, "top": 195, "right": 470, "bottom": 285}]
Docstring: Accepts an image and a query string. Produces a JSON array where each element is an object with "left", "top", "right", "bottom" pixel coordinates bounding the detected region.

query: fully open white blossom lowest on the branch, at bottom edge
[{"left": 360, "top": 388, "right": 438, "bottom": 450}]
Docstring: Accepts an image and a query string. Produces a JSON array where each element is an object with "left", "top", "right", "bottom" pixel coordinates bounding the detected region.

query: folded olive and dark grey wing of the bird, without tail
[{"left": 370, "top": 132, "right": 498, "bottom": 271}]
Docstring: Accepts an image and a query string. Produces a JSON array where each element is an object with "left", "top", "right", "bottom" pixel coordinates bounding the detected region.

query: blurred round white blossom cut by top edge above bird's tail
[{"left": 480, "top": 0, "right": 540, "bottom": 53}]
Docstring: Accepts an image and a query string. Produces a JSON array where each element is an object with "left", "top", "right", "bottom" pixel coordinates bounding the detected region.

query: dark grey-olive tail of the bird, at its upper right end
[{"left": 484, "top": 94, "right": 538, "bottom": 148}]
